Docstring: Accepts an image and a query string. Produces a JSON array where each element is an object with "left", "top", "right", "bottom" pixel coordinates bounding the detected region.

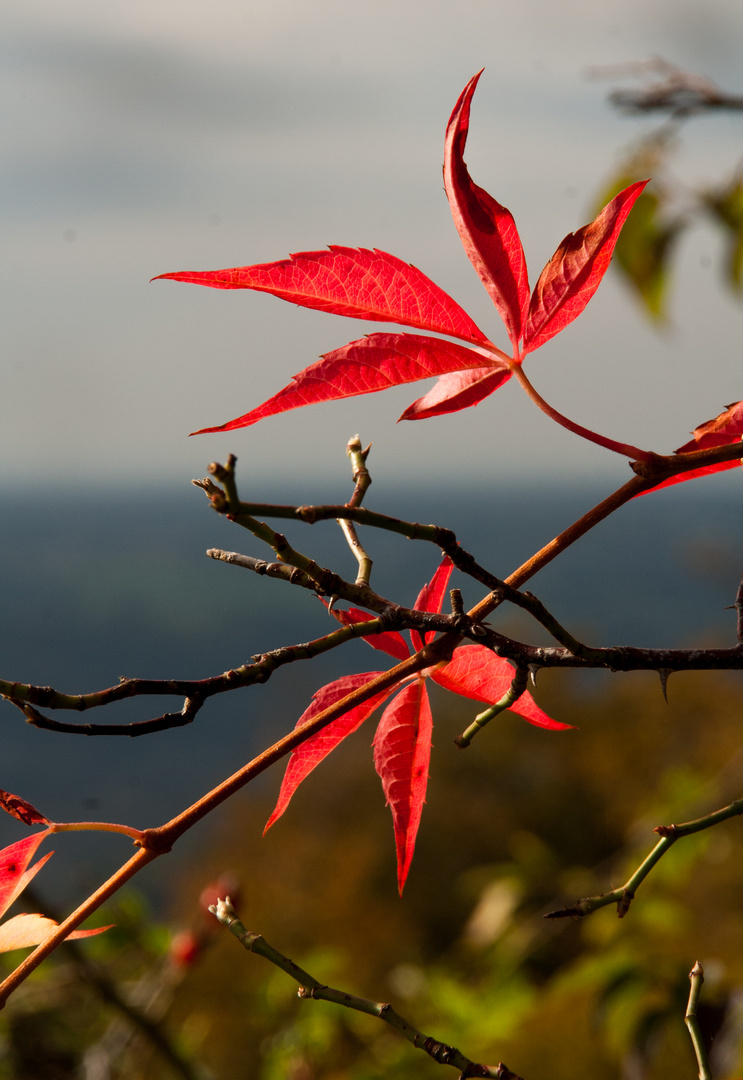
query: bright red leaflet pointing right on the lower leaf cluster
[{"left": 430, "top": 645, "right": 572, "bottom": 731}]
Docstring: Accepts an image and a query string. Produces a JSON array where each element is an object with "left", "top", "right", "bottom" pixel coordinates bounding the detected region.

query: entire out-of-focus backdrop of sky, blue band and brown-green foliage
[{"left": 0, "top": 0, "right": 743, "bottom": 1080}]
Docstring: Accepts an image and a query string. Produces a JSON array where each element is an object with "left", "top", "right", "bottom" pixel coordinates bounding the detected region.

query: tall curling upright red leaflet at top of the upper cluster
[{"left": 444, "top": 71, "right": 529, "bottom": 349}]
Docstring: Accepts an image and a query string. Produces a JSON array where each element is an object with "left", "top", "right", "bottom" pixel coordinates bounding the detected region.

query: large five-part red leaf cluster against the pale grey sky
[{"left": 155, "top": 72, "right": 645, "bottom": 445}]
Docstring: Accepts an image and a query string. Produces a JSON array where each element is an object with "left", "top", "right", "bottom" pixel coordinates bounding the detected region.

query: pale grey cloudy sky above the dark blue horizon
[{"left": 0, "top": 0, "right": 743, "bottom": 498}]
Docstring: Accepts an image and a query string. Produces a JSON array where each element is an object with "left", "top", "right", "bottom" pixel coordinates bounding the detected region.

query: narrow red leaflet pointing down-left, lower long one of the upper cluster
[{"left": 192, "top": 334, "right": 500, "bottom": 435}]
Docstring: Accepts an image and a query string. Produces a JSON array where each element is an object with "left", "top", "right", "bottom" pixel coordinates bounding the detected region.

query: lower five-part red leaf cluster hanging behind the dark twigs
[{"left": 266, "top": 555, "right": 570, "bottom": 895}]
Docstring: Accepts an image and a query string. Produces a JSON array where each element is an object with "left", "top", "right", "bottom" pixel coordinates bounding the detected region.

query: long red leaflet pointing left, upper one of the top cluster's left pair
[{"left": 152, "top": 246, "right": 488, "bottom": 345}]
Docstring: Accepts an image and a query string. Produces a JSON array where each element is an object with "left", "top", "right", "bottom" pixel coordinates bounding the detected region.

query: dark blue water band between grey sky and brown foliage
[{"left": 0, "top": 476, "right": 743, "bottom": 895}]
